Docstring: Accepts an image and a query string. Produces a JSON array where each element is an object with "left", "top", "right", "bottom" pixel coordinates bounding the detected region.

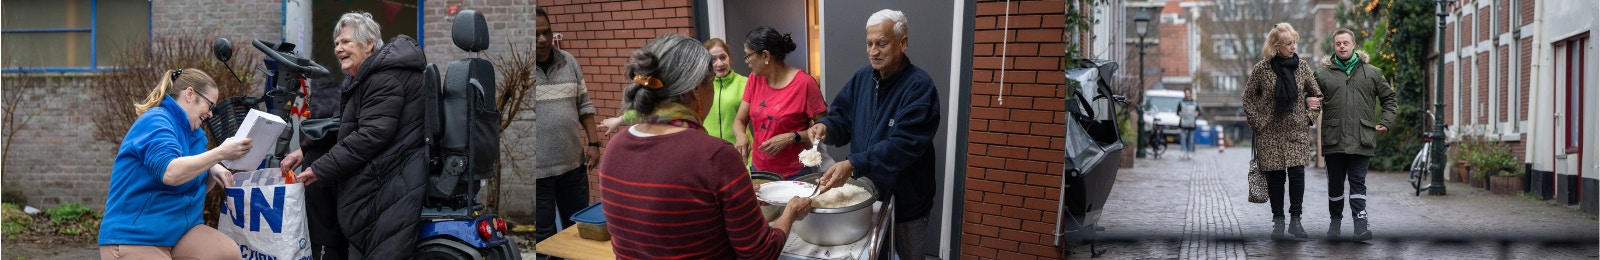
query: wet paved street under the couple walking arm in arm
[{"left": 1070, "top": 146, "right": 1600, "bottom": 258}]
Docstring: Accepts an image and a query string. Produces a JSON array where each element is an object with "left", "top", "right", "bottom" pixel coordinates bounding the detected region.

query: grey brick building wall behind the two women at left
[{"left": 3, "top": 0, "right": 550, "bottom": 220}]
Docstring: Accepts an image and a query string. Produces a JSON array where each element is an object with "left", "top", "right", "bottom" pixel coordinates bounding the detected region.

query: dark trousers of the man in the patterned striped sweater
[{"left": 533, "top": 165, "right": 589, "bottom": 241}]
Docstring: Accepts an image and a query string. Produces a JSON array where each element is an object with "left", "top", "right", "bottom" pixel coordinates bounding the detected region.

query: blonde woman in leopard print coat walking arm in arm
[{"left": 1245, "top": 24, "right": 1322, "bottom": 239}]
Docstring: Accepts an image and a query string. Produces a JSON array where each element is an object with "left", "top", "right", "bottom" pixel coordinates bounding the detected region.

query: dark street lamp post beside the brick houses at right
[{"left": 1427, "top": 0, "right": 1454, "bottom": 196}]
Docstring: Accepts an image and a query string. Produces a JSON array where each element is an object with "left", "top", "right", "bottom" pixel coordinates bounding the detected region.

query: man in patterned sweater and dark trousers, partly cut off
[{"left": 533, "top": 8, "right": 600, "bottom": 241}]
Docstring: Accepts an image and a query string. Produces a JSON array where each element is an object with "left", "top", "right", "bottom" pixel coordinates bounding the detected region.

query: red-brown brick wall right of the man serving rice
[{"left": 960, "top": 0, "right": 1066, "bottom": 260}]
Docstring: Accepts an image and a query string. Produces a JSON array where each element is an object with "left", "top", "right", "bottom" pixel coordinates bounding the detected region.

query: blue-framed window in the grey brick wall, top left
[{"left": 0, "top": 0, "right": 150, "bottom": 72}]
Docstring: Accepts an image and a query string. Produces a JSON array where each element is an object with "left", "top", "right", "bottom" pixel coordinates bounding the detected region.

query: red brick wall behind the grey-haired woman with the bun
[{"left": 539, "top": 0, "right": 694, "bottom": 201}]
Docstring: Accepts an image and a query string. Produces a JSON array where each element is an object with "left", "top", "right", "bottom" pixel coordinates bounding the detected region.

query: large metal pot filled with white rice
[{"left": 778, "top": 173, "right": 878, "bottom": 246}]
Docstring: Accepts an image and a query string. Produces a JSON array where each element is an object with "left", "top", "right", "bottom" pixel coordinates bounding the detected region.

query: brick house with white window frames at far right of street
[{"left": 1429, "top": 0, "right": 1600, "bottom": 213}]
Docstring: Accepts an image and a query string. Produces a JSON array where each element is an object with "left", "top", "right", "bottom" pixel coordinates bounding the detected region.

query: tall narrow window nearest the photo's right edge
[{"left": 1555, "top": 35, "right": 1590, "bottom": 154}]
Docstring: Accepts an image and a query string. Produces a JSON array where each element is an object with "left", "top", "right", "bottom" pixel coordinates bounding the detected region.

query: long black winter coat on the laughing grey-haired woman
[{"left": 312, "top": 35, "right": 430, "bottom": 258}]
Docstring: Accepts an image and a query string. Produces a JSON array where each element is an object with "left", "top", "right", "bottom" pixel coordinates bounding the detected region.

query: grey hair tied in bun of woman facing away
[{"left": 622, "top": 34, "right": 712, "bottom": 116}]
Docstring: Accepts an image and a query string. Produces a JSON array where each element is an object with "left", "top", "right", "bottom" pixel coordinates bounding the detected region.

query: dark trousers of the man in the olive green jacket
[{"left": 1326, "top": 154, "right": 1371, "bottom": 221}]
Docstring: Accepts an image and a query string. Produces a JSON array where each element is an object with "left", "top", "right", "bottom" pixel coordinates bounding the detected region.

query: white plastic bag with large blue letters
[{"left": 216, "top": 169, "right": 310, "bottom": 260}]
